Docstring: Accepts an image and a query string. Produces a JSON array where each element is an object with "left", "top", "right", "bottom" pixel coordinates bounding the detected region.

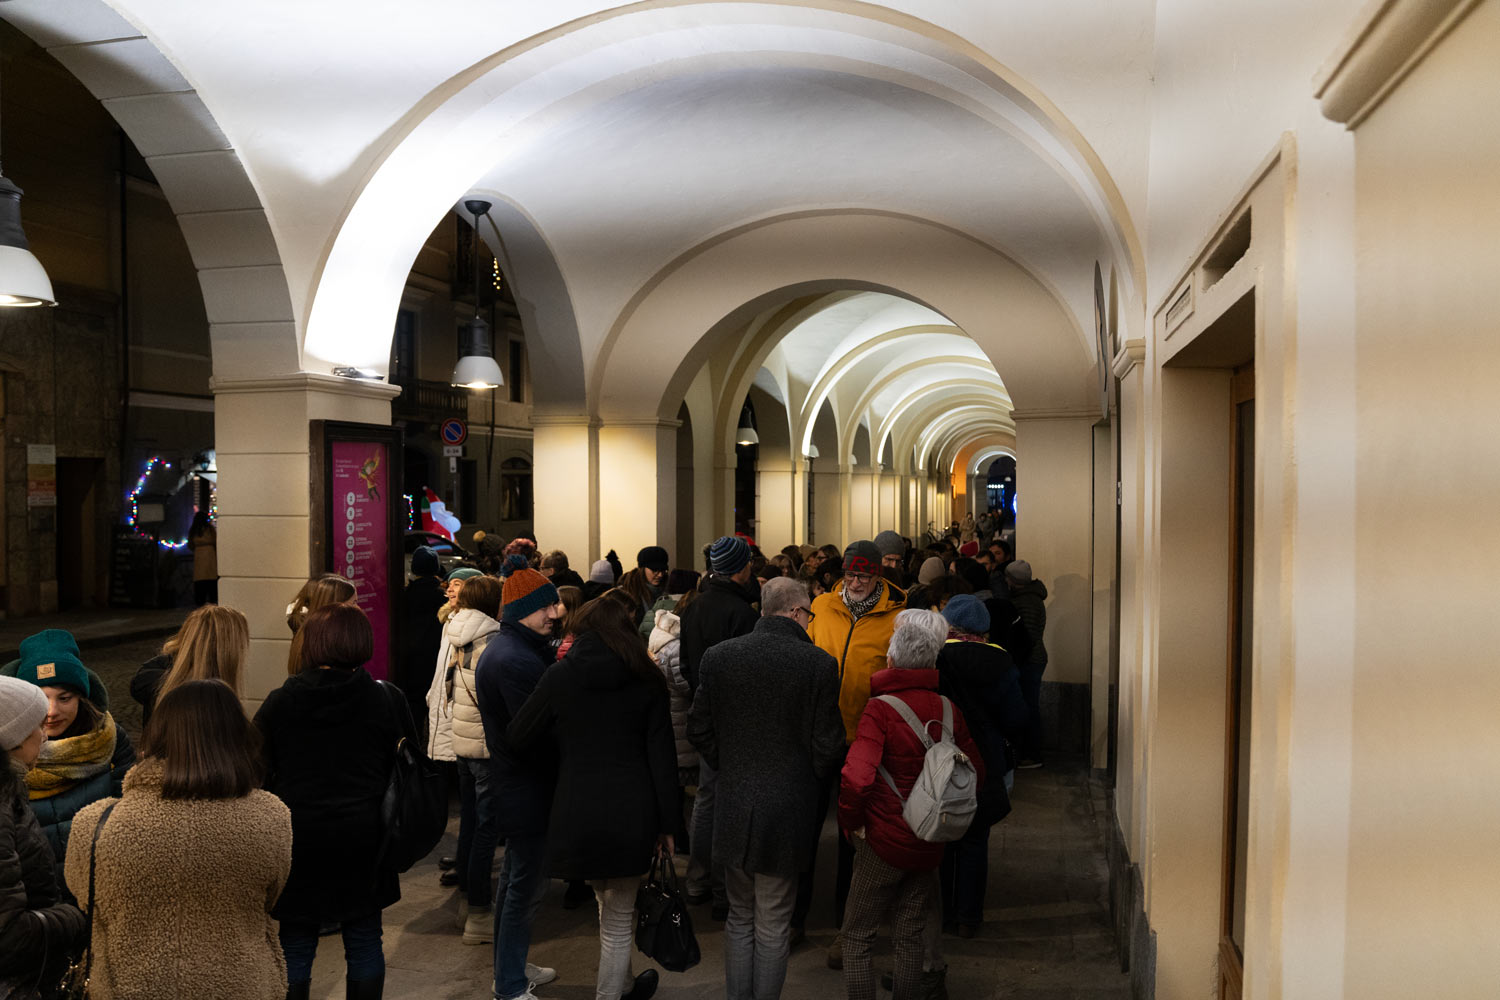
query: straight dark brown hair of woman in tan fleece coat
[{"left": 141, "top": 678, "right": 261, "bottom": 799}]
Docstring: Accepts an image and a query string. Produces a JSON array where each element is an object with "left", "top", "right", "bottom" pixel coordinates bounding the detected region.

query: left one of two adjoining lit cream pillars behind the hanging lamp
[{"left": 531, "top": 414, "right": 602, "bottom": 569}]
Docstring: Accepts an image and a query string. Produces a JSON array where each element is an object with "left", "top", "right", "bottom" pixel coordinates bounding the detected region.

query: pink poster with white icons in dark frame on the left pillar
[{"left": 330, "top": 441, "right": 392, "bottom": 681}]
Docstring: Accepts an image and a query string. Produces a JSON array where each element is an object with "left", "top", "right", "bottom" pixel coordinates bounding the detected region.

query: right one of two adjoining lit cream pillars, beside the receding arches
[{"left": 597, "top": 420, "right": 680, "bottom": 571}]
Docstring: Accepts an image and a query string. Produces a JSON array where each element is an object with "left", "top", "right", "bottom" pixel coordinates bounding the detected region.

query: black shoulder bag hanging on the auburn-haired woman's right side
[{"left": 378, "top": 681, "right": 449, "bottom": 871}]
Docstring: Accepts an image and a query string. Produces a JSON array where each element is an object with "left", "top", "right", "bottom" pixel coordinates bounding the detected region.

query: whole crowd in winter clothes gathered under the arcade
[{"left": 0, "top": 509, "right": 1047, "bottom": 1000}]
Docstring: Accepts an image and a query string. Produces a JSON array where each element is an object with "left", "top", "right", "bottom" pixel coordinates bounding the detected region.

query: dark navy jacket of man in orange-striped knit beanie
[{"left": 474, "top": 621, "right": 557, "bottom": 837}]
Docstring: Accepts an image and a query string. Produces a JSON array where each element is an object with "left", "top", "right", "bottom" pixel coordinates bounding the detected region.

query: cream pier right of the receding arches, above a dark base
[{"left": 1016, "top": 414, "right": 1097, "bottom": 684}]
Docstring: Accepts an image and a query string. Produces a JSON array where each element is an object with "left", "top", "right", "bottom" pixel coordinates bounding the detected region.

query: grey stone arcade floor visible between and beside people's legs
[{"left": 312, "top": 763, "right": 1130, "bottom": 1000}]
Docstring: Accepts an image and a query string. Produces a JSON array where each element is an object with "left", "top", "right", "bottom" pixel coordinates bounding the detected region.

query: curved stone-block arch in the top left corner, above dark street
[{"left": 5, "top": 0, "right": 298, "bottom": 382}]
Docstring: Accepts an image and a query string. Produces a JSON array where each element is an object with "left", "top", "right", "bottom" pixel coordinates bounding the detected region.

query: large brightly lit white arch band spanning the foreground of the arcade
[{"left": 303, "top": 0, "right": 1145, "bottom": 386}]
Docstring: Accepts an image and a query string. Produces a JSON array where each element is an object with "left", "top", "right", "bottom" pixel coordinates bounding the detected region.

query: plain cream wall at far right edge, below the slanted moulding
[{"left": 1343, "top": 0, "right": 1500, "bottom": 1000}]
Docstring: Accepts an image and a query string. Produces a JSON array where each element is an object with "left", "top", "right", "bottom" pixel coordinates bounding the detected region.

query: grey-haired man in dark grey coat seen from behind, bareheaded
[{"left": 687, "top": 577, "right": 845, "bottom": 1000}]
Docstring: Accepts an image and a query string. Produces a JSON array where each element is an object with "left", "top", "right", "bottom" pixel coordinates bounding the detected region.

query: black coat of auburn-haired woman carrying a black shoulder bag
[{"left": 255, "top": 667, "right": 414, "bottom": 924}]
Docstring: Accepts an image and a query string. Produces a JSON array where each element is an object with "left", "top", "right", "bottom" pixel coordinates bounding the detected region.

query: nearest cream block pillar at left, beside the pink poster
[{"left": 212, "top": 372, "right": 401, "bottom": 712}]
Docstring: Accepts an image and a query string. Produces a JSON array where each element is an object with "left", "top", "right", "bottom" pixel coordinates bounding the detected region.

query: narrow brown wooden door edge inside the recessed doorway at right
[{"left": 1220, "top": 364, "right": 1256, "bottom": 1000}]
